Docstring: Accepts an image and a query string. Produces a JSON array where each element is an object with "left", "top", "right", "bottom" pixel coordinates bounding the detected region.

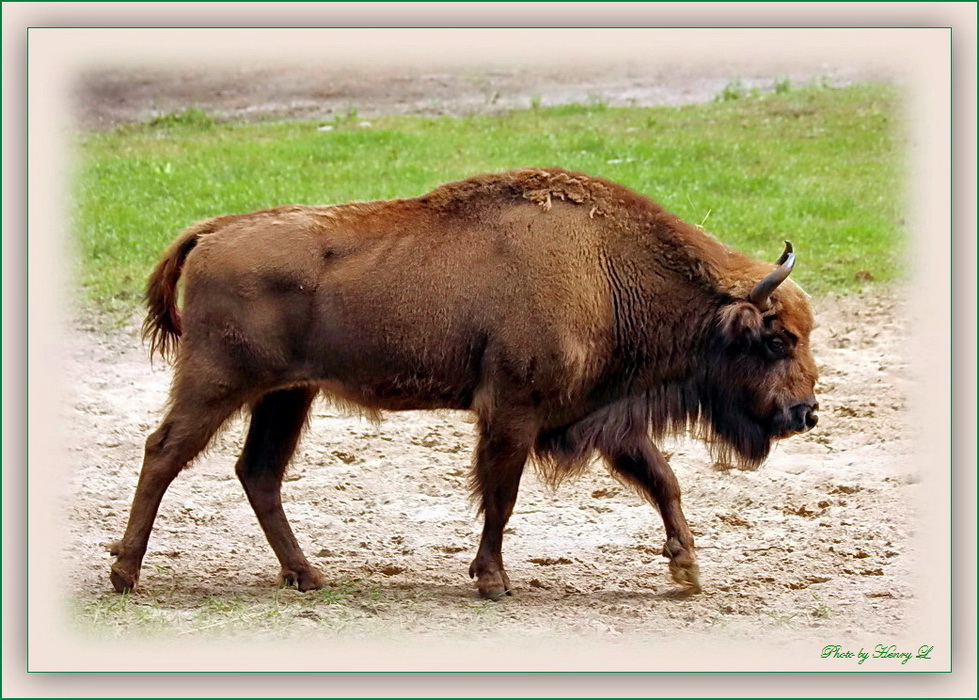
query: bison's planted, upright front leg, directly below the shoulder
[{"left": 469, "top": 416, "right": 531, "bottom": 600}]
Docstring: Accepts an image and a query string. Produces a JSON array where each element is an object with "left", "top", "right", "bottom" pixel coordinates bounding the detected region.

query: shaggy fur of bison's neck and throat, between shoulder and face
[{"left": 535, "top": 172, "right": 771, "bottom": 482}]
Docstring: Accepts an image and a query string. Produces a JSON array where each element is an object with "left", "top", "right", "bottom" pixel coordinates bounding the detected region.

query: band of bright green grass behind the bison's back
[{"left": 73, "top": 82, "right": 905, "bottom": 310}]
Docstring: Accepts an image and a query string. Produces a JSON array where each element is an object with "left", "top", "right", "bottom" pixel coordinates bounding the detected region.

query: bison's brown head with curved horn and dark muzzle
[{"left": 702, "top": 241, "right": 819, "bottom": 466}]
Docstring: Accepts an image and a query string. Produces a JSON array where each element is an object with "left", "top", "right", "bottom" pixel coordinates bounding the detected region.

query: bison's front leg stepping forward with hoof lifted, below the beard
[{"left": 605, "top": 434, "right": 700, "bottom": 593}]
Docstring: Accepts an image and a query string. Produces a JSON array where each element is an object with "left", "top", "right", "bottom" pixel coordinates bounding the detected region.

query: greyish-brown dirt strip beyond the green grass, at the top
[{"left": 74, "top": 60, "right": 889, "bottom": 129}]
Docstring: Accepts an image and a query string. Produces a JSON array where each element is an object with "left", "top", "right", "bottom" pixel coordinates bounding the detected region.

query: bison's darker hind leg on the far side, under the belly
[{"left": 235, "top": 387, "right": 323, "bottom": 591}]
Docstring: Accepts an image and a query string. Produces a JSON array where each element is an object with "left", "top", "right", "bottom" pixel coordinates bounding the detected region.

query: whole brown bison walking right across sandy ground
[{"left": 111, "top": 169, "right": 817, "bottom": 599}]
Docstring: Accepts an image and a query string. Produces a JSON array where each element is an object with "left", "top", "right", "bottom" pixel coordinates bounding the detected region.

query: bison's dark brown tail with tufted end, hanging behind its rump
[{"left": 143, "top": 219, "right": 216, "bottom": 360}]
